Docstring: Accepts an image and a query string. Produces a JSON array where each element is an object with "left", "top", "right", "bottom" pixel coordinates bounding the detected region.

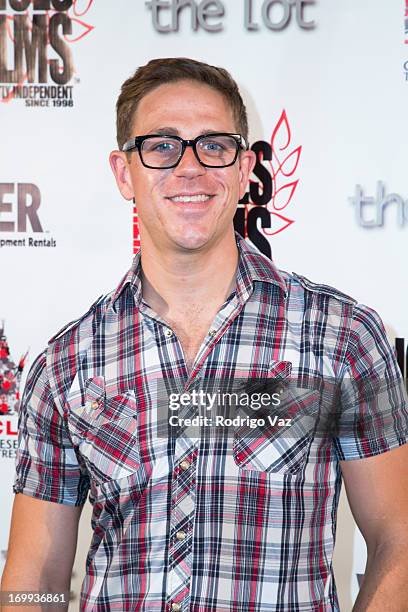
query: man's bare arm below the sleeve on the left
[{"left": 1, "top": 493, "right": 82, "bottom": 612}]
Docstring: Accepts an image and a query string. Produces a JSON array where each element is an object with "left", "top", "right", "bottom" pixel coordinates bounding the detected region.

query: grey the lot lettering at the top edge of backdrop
[{"left": 145, "top": 0, "right": 316, "bottom": 33}]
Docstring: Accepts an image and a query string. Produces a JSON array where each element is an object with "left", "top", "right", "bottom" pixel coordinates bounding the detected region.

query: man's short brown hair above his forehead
[{"left": 116, "top": 57, "right": 248, "bottom": 149}]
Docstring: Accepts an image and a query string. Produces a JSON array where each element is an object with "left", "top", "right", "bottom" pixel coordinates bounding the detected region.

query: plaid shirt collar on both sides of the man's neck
[{"left": 112, "top": 232, "right": 287, "bottom": 311}]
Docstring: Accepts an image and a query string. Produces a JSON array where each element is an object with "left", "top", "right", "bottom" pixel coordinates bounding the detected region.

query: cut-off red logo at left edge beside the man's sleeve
[{"left": 0, "top": 320, "right": 28, "bottom": 459}]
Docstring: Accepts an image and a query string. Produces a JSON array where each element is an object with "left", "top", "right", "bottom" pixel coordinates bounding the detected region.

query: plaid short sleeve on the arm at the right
[{"left": 334, "top": 304, "right": 408, "bottom": 461}]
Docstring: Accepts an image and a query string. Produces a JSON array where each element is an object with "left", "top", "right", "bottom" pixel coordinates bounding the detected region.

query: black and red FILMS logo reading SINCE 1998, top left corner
[{"left": 0, "top": 0, "right": 94, "bottom": 108}]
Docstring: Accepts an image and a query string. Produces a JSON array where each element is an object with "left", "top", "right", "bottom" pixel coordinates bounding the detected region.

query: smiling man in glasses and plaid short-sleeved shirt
[{"left": 3, "top": 59, "right": 408, "bottom": 612}]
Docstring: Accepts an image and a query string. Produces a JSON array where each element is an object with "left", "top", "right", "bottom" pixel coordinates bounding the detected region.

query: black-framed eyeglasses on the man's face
[{"left": 122, "top": 132, "right": 248, "bottom": 170}]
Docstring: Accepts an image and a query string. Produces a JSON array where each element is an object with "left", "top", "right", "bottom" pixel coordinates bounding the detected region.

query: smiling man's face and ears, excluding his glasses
[{"left": 111, "top": 81, "right": 255, "bottom": 250}]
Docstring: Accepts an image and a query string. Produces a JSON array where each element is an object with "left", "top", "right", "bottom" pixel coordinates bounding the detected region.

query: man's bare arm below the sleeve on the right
[{"left": 340, "top": 444, "right": 408, "bottom": 612}]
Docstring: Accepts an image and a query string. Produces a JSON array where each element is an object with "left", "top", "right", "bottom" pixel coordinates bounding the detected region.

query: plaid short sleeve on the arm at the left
[{"left": 13, "top": 351, "right": 90, "bottom": 506}]
